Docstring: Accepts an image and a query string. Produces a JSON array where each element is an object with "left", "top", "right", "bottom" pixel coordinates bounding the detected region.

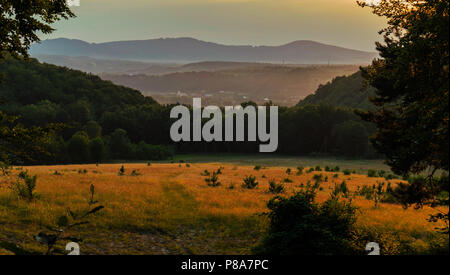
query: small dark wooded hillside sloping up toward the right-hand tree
[{"left": 298, "top": 72, "right": 375, "bottom": 110}]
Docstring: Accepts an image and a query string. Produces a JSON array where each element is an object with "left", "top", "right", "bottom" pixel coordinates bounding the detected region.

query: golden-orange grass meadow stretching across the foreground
[{"left": 0, "top": 163, "right": 448, "bottom": 254}]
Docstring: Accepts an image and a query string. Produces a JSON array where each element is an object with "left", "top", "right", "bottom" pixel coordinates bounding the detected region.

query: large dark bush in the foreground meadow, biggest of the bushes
[{"left": 254, "top": 186, "right": 356, "bottom": 255}]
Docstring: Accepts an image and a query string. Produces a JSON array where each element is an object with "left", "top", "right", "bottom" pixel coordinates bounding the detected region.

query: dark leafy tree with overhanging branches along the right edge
[{"left": 359, "top": 0, "right": 450, "bottom": 232}]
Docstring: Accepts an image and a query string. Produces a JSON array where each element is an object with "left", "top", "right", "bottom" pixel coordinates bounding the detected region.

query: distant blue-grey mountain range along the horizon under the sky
[{"left": 30, "top": 38, "right": 377, "bottom": 64}]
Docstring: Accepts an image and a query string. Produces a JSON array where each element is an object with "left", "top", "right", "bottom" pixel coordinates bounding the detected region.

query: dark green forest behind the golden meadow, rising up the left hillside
[{"left": 0, "top": 58, "right": 375, "bottom": 163}]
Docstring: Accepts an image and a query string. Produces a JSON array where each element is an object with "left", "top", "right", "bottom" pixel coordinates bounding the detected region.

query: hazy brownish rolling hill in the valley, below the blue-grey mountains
[{"left": 100, "top": 63, "right": 359, "bottom": 106}]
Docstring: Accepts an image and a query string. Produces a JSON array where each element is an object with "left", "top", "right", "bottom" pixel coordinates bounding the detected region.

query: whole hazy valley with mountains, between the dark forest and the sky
[{"left": 31, "top": 38, "right": 366, "bottom": 106}]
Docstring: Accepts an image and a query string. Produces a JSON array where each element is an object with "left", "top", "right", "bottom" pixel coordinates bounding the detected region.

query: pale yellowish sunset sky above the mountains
[{"left": 45, "top": 0, "right": 385, "bottom": 51}]
